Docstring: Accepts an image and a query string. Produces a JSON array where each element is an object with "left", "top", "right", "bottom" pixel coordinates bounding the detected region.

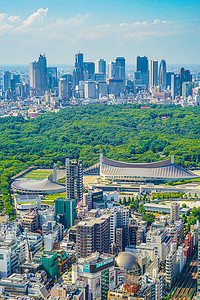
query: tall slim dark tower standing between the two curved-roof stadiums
[{"left": 66, "top": 158, "right": 83, "bottom": 202}]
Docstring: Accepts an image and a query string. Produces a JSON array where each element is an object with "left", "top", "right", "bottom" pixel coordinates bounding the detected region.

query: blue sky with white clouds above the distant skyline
[{"left": 0, "top": 0, "right": 200, "bottom": 64}]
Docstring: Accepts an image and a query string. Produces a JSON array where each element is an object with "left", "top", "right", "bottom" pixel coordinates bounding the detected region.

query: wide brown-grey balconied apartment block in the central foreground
[{"left": 76, "top": 215, "right": 110, "bottom": 258}]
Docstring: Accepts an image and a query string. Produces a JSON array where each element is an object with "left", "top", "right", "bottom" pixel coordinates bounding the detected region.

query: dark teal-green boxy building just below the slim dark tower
[{"left": 54, "top": 198, "right": 76, "bottom": 228}]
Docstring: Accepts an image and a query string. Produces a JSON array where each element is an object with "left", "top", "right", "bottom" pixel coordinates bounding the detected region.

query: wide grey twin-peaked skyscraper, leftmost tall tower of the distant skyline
[{"left": 30, "top": 54, "right": 48, "bottom": 96}]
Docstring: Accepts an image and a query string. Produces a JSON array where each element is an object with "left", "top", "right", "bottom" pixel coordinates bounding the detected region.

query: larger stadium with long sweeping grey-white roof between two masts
[{"left": 84, "top": 154, "right": 198, "bottom": 181}]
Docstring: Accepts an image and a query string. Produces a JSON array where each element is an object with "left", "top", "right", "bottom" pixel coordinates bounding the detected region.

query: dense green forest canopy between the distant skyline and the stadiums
[{"left": 0, "top": 104, "right": 200, "bottom": 213}]
